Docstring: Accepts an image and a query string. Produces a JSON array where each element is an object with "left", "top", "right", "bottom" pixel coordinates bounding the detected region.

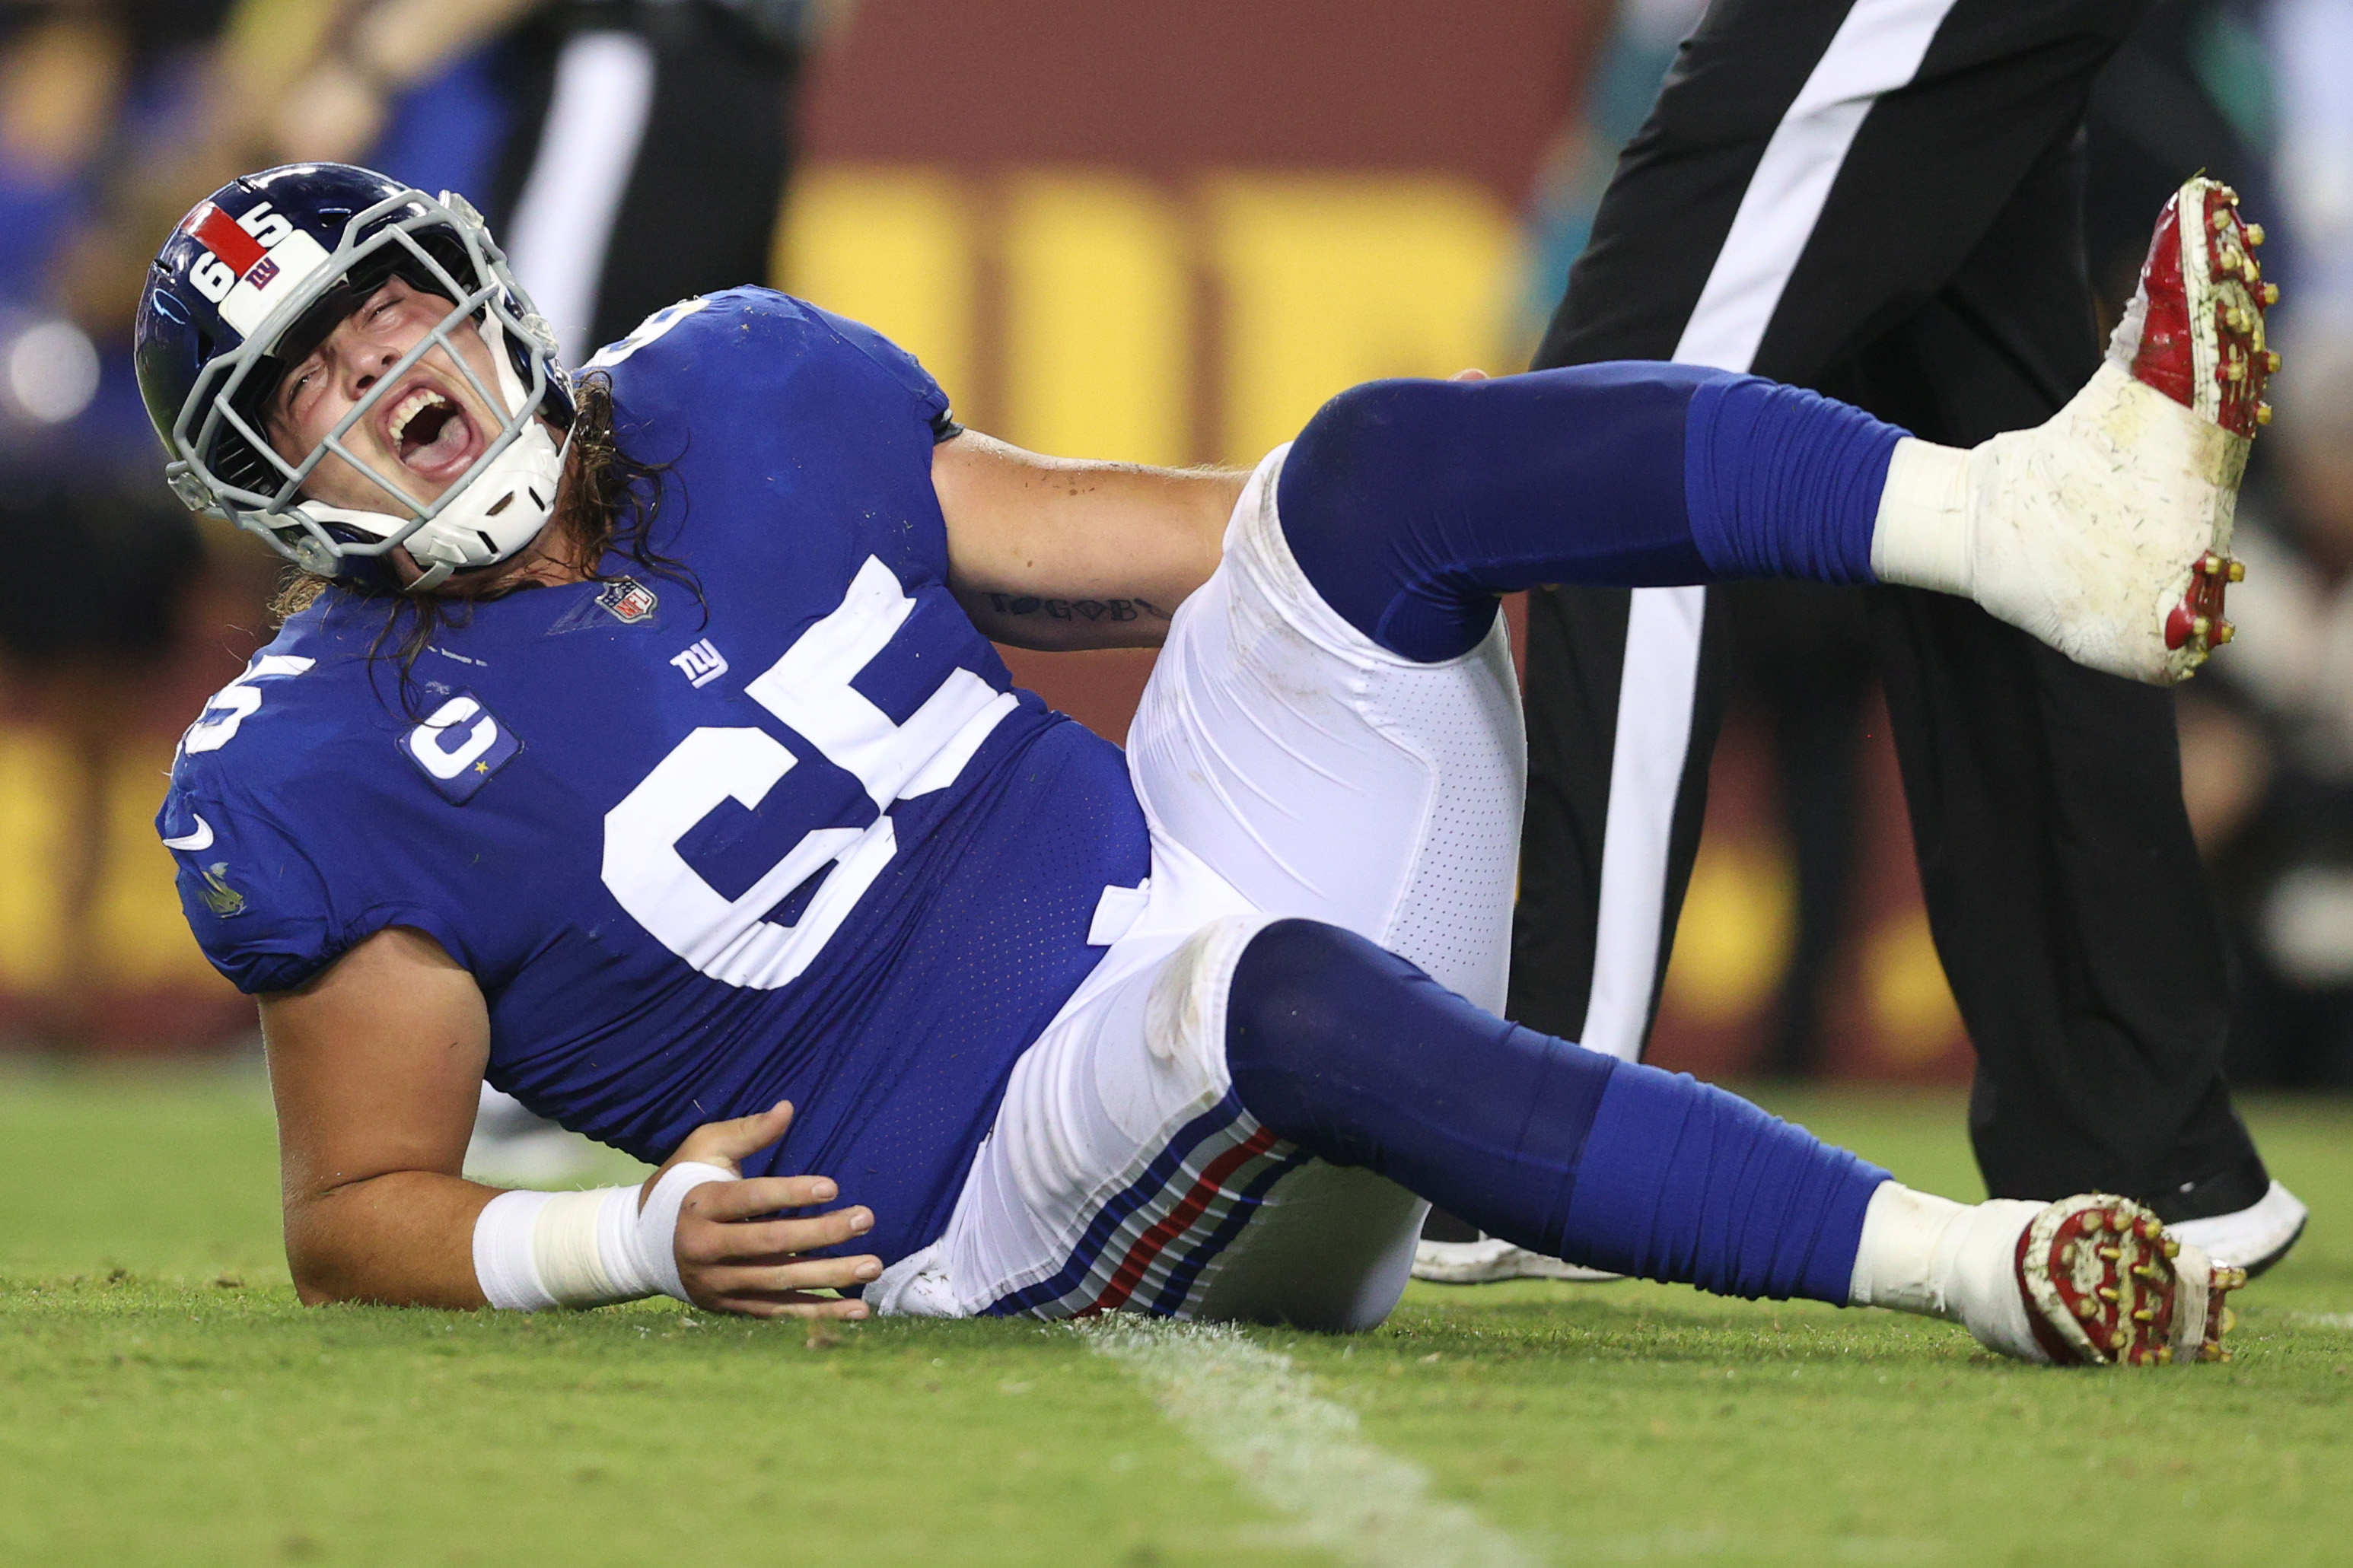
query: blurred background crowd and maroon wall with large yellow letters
[{"left": 0, "top": 0, "right": 2353, "bottom": 1086}]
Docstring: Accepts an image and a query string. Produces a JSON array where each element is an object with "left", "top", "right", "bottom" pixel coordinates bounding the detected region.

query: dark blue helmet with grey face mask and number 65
[{"left": 136, "top": 164, "right": 572, "bottom": 593}]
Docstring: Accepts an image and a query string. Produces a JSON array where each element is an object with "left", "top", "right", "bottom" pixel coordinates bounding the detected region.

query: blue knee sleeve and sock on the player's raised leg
[{"left": 1275, "top": 360, "right": 1903, "bottom": 663}]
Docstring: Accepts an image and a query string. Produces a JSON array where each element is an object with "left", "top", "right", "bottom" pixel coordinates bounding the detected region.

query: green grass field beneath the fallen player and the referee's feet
[{"left": 0, "top": 1070, "right": 2353, "bottom": 1568}]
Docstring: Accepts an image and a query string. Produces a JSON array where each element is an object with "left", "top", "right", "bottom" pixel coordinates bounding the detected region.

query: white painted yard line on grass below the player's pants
[{"left": 1080, "top": 1314, "right": 1534, "bottom": 1568}]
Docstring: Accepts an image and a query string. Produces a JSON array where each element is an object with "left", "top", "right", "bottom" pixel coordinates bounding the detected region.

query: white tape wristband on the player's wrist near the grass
[{"left": 473, "top": 1159, "right": 734, "bottom": 1312}]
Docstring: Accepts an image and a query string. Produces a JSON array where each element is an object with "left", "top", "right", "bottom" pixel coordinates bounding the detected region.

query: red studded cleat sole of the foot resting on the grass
[{"left": 2017, "top": 1192, "right": 2247, "bottom": 1366}]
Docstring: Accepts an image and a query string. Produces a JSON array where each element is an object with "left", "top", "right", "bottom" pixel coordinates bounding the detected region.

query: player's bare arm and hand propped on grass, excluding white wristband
[{"left": 261, "top": 926, "right": 883, "bottom": 1318}]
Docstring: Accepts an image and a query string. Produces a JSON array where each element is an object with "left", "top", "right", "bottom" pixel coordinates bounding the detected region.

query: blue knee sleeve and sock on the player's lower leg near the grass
[{"left": 1226, "top": 919, "right": 1887, "bottom": 1302}]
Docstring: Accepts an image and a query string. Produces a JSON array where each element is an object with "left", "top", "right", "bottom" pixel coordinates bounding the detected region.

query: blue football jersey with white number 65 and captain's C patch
[{"left": 158, "top": 289, "right": 1148, "bottom": 1258}]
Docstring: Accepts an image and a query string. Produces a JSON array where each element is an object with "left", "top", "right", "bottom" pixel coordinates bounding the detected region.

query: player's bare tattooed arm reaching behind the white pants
[{"left": 931, "top": 430, "right": 1250, "bottom": 651}]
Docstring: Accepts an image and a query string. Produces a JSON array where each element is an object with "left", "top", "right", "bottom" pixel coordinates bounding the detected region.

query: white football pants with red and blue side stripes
[{"left": 866, "top": 447, "right": 1527, "bottom": 1328}]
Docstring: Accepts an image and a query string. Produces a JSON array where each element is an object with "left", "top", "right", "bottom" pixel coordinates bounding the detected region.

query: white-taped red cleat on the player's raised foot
[{"left": 1873, "top": 179, "right": 2278, "bottom": 686}]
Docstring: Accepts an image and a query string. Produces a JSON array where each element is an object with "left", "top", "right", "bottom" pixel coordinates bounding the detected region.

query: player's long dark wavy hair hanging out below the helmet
[{"left": 271, "top": 371, "right": 704, "bottom": 717}]
